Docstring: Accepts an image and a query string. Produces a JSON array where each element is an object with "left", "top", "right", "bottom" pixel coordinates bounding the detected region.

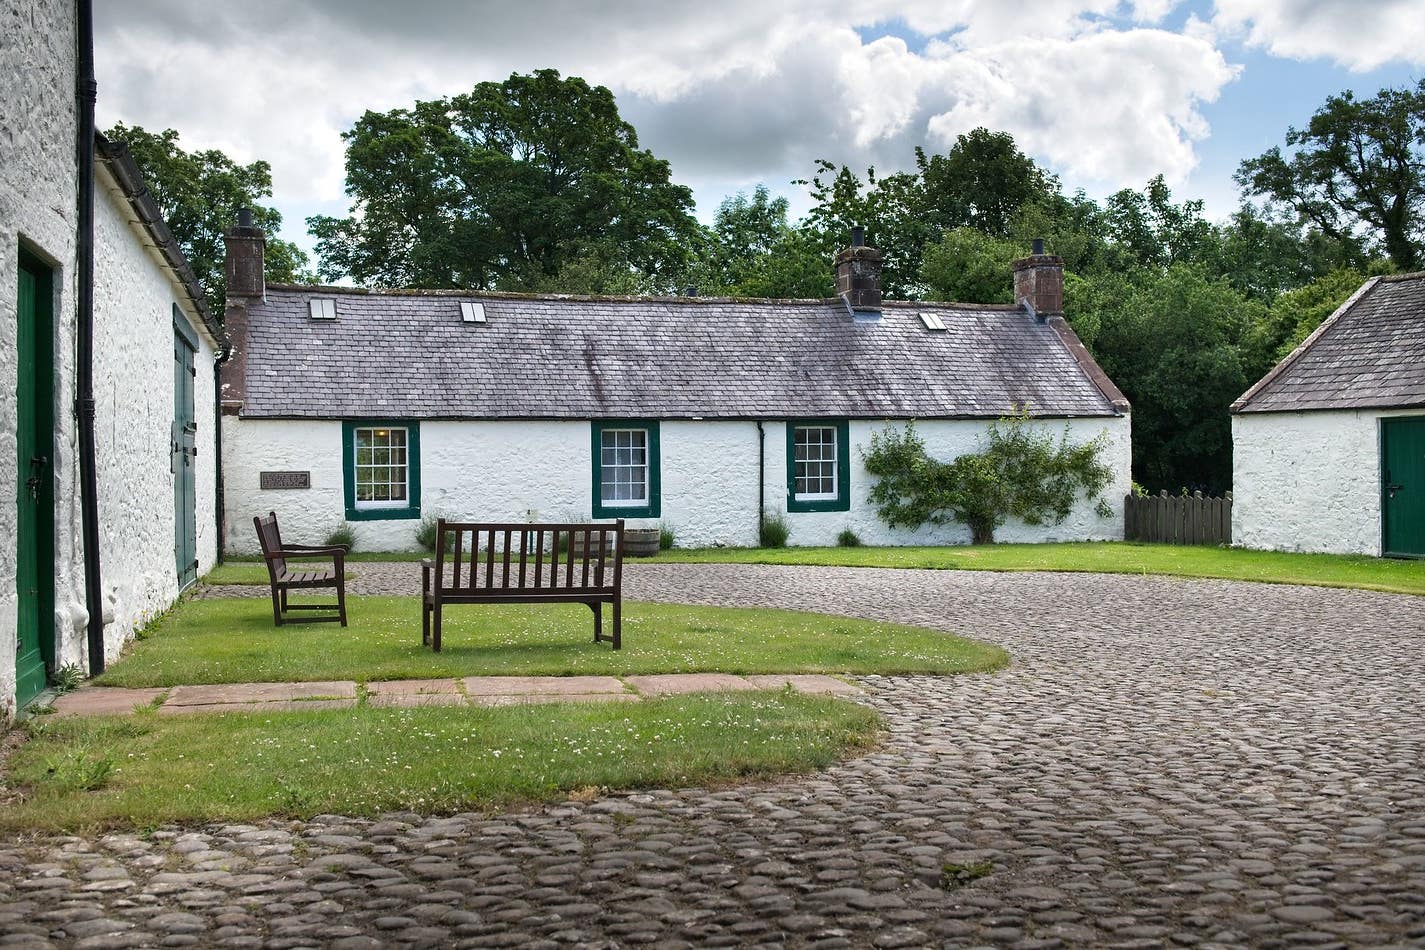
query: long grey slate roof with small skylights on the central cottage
[{"left": 241, "top": 286, "right": 1127, "bottom": 419}]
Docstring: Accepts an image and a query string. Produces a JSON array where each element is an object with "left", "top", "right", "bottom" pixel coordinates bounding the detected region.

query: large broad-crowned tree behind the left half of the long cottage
[{"left": 308, "top": 70, "right": 697, "bottom": 289}]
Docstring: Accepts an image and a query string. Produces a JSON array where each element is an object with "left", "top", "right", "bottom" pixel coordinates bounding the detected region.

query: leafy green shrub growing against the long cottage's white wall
[{"left": 862, "top": 413, "right": 1113, "bottom": 544}]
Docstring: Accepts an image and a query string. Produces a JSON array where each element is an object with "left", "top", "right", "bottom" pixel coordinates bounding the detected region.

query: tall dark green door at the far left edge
[{"left": 16, "top": 254, "right": 54, "bottom": 706}]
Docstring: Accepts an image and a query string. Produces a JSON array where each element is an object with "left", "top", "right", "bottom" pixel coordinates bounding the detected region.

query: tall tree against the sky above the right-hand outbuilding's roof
[{"left": 1235, "top": 80, "right": 1425, "bottom": 271}]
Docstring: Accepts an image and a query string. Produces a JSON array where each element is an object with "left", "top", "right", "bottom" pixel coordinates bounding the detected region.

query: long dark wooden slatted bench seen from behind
[{"left": 420, "top": 518, "right": 624, "bottom": 652}]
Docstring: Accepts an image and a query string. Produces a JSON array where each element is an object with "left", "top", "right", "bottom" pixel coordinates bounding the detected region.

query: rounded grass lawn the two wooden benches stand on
[{"left": 98, "top": 597, "right": 1006, "bottom": 687}]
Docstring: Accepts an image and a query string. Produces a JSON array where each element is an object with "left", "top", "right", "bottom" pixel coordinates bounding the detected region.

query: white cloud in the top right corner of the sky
[{"left": 1213, "top": 0, "right": 1425, "bottom": 71}]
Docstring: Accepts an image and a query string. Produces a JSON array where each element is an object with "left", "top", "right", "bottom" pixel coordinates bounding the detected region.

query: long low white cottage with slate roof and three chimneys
[{"left": 222, "top": 226, "right": 1130, "bottom": 553}]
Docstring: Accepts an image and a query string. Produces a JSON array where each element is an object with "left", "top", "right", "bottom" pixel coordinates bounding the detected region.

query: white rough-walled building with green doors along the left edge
[{"left": 0, "top": 0, "right": 224, "bottom": 718}]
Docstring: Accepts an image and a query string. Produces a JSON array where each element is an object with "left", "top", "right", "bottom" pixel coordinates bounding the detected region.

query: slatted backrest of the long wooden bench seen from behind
[{"left": 436, "top": 518, "right": 624, "bottom": 594}]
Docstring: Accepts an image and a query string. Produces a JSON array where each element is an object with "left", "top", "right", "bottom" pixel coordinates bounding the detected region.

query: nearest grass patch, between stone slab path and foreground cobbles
[{"left": 0, "top": 691, "right": 876, "bottom": 830}]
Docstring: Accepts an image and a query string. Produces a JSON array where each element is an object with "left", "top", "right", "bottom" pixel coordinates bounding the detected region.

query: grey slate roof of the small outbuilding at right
[{"left": 1233, "top": 273, "right": 1425, "bottom": 412}]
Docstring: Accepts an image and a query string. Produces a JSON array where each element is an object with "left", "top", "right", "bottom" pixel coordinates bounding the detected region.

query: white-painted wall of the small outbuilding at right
[{"left": 1233, "top": 410, "right": 1419, "bottom": 557}]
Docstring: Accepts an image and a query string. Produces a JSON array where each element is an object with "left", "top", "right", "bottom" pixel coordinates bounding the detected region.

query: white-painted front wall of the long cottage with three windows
[{"left": 224, "top": 416, "right": 1130, "bottom": 553}]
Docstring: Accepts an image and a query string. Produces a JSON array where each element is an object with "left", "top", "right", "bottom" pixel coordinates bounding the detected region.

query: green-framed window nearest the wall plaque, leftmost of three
[{"left": 342, "top": 419, "right": 420, "bottom": 521}]
